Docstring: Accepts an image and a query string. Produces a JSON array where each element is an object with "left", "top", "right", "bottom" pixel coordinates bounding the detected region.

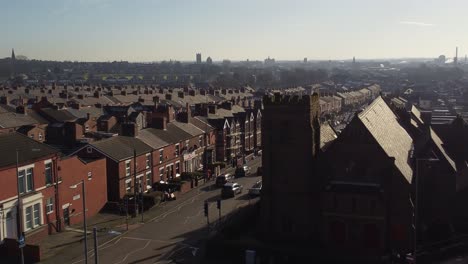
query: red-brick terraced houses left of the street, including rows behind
[{"left": 0, "top": 83, "right": 262, "bottom": 258}]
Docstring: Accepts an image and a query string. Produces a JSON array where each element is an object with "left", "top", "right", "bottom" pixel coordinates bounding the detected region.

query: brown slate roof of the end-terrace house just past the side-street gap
[{"left": 90, "top": 136, "right": 152, "bottom": 161}]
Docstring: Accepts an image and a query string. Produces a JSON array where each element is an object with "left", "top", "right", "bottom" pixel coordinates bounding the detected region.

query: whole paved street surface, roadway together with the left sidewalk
[{"left": 41, "top": 157, "right": 261, "bottom": 264}]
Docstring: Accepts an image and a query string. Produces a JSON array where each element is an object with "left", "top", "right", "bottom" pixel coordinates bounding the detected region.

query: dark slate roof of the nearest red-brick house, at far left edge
[{"left": 0, "top": 132, "right": 59, "bottom": 167}]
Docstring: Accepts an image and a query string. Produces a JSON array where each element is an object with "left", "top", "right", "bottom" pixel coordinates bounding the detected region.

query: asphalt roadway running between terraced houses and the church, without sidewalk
[{"left": 45, "top": 157, "right": 261, "bottom": 264}]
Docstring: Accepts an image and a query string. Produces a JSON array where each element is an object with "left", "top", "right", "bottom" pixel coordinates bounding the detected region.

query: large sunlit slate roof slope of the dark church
[{"left": 358, "top": 96, "right": 413, "bottom": 182}]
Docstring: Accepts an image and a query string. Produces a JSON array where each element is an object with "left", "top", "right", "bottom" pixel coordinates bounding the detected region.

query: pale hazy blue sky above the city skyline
[{"left": 0, "top": 0, "right": 468, "bottom": 62}]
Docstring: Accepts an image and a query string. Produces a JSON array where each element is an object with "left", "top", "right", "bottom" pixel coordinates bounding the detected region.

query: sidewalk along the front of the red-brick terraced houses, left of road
[{"left": 39, "top": 157, "right": 259, "bottom": 263}]
